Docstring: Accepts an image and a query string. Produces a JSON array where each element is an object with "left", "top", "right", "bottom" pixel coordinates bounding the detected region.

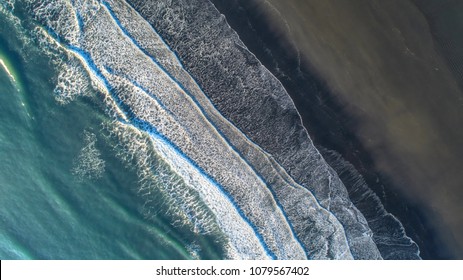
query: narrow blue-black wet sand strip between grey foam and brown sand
[{"left": 212, "top": 0, "right": 453, "bottom": 259}]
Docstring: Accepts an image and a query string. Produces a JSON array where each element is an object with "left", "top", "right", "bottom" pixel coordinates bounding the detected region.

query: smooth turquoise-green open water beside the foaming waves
[{"left": 0, "top": 4, "right": 223, "bottom": 259}]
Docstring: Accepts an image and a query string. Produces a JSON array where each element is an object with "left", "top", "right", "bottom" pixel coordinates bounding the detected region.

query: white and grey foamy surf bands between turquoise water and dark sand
[{"left": 0, "top": 0, "right": 419, "bottom": 259}]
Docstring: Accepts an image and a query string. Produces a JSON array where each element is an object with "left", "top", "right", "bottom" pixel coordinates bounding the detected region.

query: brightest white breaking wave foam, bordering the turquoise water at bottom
[{"left": 110, "top": 122, "right": 269, "bottom": 259}]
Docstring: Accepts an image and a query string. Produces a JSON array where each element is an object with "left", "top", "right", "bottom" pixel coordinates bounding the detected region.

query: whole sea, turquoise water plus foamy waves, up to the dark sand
[{"left": 0, "top": 0, "right": 420, "bottom": 259}]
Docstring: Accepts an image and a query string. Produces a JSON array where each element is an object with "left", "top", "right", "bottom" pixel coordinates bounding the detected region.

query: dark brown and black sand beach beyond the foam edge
[{"left": 215, "top": 0, "right": 463, "bottom": 258}]
